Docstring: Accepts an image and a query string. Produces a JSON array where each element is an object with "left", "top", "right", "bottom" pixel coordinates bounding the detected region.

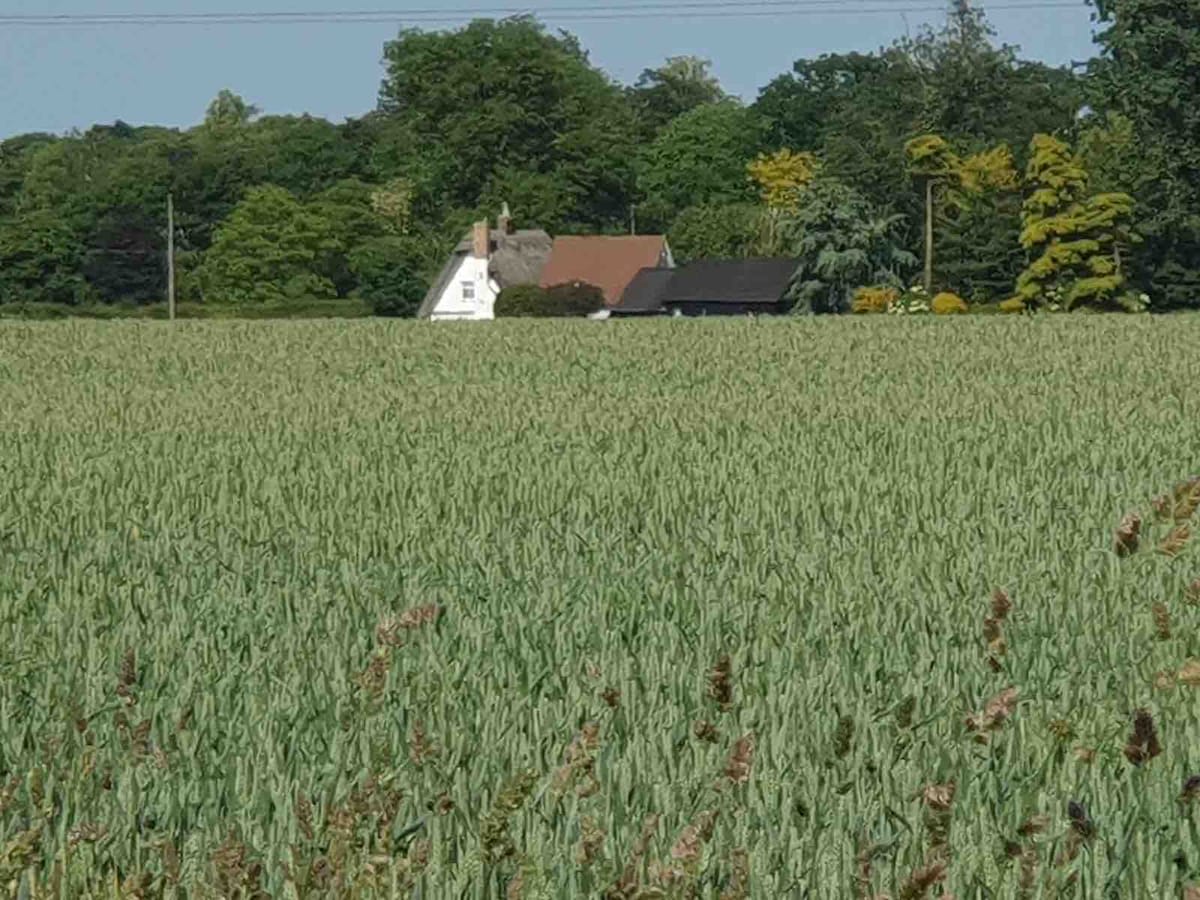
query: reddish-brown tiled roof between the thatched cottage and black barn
[{"left": 540, "top": 235, "right": 667, "bottom": 306}]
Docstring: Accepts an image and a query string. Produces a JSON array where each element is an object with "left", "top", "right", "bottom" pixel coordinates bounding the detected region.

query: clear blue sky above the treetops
[{"left": 0, "top": 0, "right": 1093, "bottom": 139}]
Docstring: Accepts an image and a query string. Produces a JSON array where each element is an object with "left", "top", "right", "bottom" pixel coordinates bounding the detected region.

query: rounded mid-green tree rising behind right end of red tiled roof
[{"left": 638, "top": 101, "right": 761, "bottom": 228}]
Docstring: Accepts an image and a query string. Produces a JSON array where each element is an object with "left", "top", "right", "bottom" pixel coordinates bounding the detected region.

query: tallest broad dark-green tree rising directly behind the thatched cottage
[{"left": 379, "top": 18, "right": 636, "bottom": 227}]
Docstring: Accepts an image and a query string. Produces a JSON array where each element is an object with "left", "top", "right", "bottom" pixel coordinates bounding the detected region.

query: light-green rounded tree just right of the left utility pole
[{"left": 197, "top": 186, "right": 342, "bottom": 304}]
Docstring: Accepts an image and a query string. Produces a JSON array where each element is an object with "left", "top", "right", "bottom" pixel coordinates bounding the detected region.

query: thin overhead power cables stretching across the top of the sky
[{"left": 0, "top": 0, "right": 1084, "bottom": 28}]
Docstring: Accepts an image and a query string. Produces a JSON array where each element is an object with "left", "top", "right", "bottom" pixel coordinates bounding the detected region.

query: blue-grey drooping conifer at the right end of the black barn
[{"left": 785, "top": 178, "right": 917, "bottom": 313}]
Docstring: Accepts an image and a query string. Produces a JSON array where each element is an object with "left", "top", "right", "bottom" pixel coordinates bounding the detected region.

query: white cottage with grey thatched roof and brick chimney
[{"left": 416, "top": 204, "right": 553, "bottom": 322}]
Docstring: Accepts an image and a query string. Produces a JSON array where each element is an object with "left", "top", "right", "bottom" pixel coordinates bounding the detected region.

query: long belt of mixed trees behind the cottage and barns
[{"left": 0, "top": 0, "right": 1200, "bottom": 316}]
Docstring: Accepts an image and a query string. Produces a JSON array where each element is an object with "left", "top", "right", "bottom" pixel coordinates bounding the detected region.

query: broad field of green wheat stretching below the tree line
[{"left": 0, "top": 316, "right": 1200, "bottom": 900}]
